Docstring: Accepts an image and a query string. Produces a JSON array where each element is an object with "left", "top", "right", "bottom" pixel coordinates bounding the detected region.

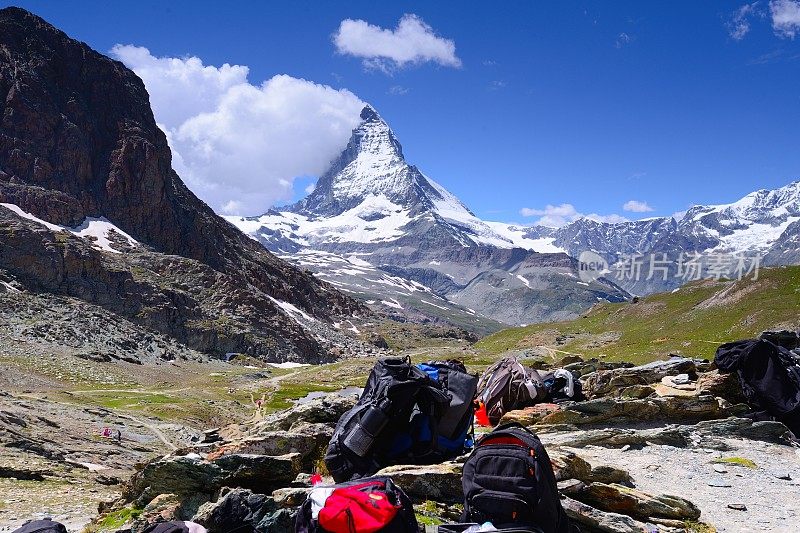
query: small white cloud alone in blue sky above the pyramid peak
[{"left": 333, "top": 14, "right": 461, "bottom": 72}]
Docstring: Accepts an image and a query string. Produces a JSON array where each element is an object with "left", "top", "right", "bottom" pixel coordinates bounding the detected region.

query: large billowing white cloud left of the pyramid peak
[{"left": 111, "top": 45, "right": 364, "bottom": 215}]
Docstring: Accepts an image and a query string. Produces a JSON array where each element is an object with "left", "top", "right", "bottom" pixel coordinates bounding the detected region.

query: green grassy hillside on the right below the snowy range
[{"left": 476, "top": 266, "right": 800, "bottom": 362}]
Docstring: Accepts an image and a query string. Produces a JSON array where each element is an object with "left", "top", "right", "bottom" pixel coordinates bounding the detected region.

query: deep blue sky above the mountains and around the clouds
[{"left": 6, "top": 0, "right": 800, "bottom": 223}]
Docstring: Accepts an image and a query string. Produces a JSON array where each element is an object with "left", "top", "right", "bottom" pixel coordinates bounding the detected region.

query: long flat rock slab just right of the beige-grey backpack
[{"left": 581, "top": 358, "right": 696, "bottom": 398}]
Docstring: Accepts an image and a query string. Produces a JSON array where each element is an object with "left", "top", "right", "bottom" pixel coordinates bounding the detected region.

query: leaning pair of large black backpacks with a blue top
[{"left": 325, "top": 357, "right": 478, "bottom": 482}]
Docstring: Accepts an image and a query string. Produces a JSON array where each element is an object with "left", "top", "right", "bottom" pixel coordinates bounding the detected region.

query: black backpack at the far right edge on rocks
[{"left": 714, "top": 339, "right": 800, "bottom": 438}]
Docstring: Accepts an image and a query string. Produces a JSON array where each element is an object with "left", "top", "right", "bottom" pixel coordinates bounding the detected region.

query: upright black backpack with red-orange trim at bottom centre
[{"left": 461, "top": 424, "right": 578, "bottom": 533}]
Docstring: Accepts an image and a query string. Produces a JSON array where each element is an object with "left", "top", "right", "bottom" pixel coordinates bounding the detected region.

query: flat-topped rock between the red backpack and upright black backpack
[{"left": 375, "top": 462, "right": 464, "bottom": 503}]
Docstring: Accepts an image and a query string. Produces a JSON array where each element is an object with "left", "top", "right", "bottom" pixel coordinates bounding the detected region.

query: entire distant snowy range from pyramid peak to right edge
[{"left": 227, "top": 105, "right": 800, "bottom": 332}]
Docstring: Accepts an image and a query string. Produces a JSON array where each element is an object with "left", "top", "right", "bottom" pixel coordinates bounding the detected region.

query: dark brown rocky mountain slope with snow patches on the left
[{"left": 0, "top": 8, "right": 368, "bottom": 361}]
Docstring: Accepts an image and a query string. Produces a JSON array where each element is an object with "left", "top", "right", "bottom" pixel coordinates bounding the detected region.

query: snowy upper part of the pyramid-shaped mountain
[{"left": 230, "top": 105, "right": 559, "bottom": 252}]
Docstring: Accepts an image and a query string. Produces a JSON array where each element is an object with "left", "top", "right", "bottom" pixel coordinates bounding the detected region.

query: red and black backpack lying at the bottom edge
[{"left": 295, "top": 476, "right": 419, "bottom": 533}]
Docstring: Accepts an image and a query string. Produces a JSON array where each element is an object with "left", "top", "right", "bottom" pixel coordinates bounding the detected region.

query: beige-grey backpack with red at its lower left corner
[{"left": 478, "top": 357, "right": 548, "bottom": 424}]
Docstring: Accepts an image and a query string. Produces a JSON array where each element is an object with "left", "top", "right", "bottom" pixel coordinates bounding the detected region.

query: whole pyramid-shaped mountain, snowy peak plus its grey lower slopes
[{"left": 228, "top": 106, "right": 627, "bottom": 329}]
